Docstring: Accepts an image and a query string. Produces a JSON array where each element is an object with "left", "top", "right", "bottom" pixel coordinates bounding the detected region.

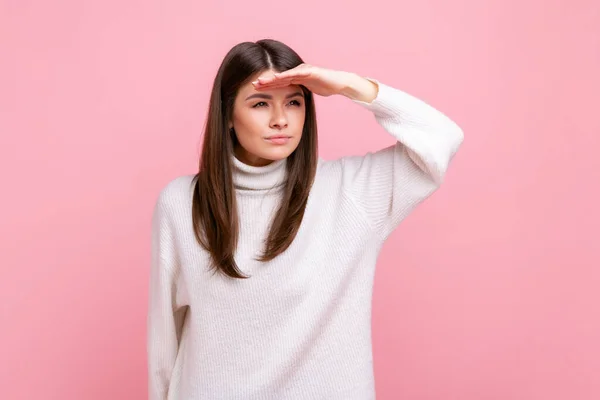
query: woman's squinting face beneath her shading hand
[{"left": 229, "top": 71, "right": 306, "bottom": 166}]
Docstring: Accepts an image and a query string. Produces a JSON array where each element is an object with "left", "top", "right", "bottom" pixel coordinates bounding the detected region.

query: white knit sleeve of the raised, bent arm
[{"left": 342, "top": 80, "right": 463, "bottom": 239}]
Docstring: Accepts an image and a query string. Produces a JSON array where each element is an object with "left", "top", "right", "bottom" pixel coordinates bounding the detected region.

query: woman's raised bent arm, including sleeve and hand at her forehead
[{"left": 255, "top": 64, "right": 463, "bottom": 238}]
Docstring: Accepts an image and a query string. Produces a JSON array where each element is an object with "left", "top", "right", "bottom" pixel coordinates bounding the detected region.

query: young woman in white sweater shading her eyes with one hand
[{"left": 148, "top": 40, "right": 463, "bottom": 400}]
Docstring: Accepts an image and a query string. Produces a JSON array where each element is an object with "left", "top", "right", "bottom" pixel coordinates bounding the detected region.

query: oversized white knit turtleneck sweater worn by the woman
[{"left": 147, "top": 79, "right": 463, "bottom": 400}]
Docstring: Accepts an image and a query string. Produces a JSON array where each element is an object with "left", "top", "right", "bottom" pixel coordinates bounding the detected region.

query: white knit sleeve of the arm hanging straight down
[{"left": 147, "top": 196, "right": 183, "bottom": 400}]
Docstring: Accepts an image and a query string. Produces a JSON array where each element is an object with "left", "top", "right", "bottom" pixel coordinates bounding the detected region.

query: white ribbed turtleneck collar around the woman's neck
[{"left": 233, "top": 157, "right": 287, "bottom": 190}]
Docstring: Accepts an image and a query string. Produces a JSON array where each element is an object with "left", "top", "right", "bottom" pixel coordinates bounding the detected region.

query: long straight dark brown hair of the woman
[{"left": 192, "top": 39, "right": 317, "bottom": 278}]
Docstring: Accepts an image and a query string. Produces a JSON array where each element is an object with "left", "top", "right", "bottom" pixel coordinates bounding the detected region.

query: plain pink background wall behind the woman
[{"left": 0, "top": 0, "right": 600, "bottom": 400}]
